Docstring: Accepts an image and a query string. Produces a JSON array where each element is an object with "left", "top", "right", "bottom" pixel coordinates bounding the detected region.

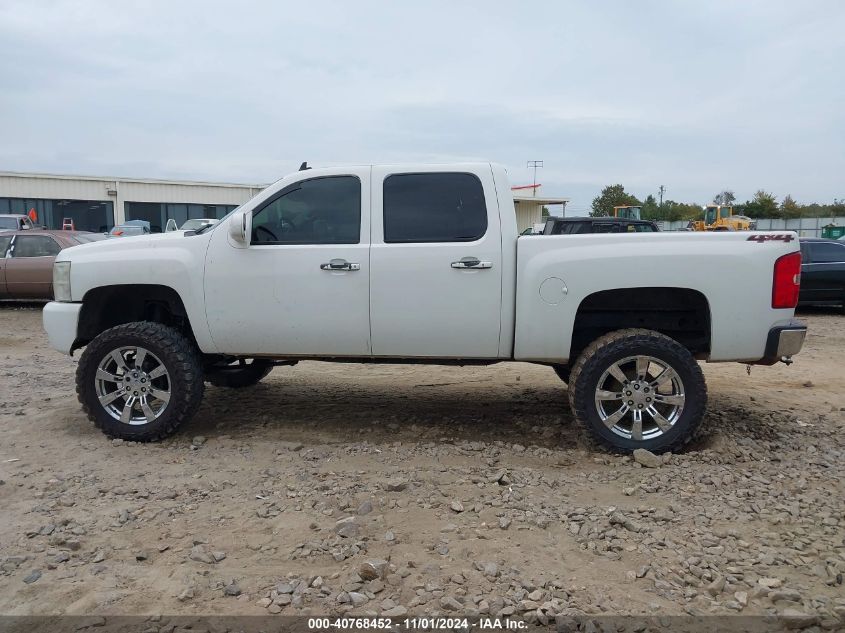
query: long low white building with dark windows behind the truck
[{"left": 0, "top": 172, "right": 568, "bottom": 232}]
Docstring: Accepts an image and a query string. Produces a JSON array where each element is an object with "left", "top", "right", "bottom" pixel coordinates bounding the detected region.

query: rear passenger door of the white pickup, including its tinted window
[{"left": 370, "top": 166, "right": 502, "bottom": 358}]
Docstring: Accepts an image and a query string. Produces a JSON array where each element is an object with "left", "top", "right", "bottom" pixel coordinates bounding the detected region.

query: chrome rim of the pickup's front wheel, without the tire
[{"left": 94, "top": 347, "right": 171, "bottom": 425}]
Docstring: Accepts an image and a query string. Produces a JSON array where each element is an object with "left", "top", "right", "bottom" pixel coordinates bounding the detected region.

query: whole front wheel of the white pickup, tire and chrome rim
[{"left": 76, "top": 321, "right": 203, "bottom": 442}]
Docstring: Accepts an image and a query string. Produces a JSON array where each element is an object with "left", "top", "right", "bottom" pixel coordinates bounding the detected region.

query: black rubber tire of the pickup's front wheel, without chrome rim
[{"left": 76, "top": 321, "right": 204, "bottom": 442}]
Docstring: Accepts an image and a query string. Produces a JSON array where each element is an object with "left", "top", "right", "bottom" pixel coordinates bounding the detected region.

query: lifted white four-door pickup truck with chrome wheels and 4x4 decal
[{"left": 43, "top": 163, "right": 806, "bottom": 451}]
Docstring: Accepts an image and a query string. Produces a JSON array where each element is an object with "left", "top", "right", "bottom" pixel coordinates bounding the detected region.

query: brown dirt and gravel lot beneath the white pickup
[{"left": 0, "top": 305, "right": 845, "bottom": 628}]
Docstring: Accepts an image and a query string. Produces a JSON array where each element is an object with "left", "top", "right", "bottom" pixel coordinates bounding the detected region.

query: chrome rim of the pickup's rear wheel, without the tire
[{"left": 595, "top": 356, "right": 686, "bottom": 441}]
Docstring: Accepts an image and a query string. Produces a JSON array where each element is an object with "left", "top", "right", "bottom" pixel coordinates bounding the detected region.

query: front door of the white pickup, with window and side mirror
[{"left": 205, "top": 167, "right": 370, "bottom": 356}]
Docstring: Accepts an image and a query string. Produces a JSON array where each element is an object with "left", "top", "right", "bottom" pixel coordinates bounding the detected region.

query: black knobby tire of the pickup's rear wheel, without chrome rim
[{"left": 569, "top": 329, "right": 707, "bottom": 453}]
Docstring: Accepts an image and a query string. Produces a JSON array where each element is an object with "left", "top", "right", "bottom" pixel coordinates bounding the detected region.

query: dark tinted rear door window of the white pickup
[{"left": 384, "top": 173, "right": 487, "bottom": 243}]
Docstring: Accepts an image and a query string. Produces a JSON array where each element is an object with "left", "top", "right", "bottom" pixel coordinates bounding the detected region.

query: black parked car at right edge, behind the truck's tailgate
[{"left": 798, "top": 238, "right": 845, "bottom": 312}]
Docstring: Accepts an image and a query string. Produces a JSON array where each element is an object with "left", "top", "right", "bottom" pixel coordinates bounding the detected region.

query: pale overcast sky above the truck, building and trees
[{"left": 0, "top": 0, "right": 845, "bottom": 212}]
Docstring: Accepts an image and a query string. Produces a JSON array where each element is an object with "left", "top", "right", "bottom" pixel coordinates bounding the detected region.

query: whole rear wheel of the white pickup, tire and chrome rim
[{"left": 569, "top": 329, "right": 707, "bottom": 453}]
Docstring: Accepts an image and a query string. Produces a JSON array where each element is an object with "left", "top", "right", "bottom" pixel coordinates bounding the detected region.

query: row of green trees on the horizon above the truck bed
[{"left": 590, "top": 184, "right": 845, "bottom": 222}]
